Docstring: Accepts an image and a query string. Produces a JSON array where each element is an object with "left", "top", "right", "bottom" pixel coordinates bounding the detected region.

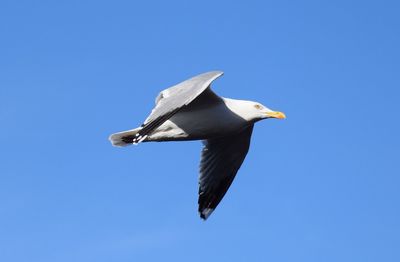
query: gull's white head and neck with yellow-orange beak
[{"left": 227, "top": 99, "right": 286, "bottom": 122}]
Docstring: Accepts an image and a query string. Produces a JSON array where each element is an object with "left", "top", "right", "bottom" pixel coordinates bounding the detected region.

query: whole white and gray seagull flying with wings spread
[{"left": 109, "top": 71, "right": 286, "bottom": 220}]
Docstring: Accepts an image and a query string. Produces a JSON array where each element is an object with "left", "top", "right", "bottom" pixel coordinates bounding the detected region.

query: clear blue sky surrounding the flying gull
[{"left": 0, "top": 0, "right": 400, "bottom": 262}]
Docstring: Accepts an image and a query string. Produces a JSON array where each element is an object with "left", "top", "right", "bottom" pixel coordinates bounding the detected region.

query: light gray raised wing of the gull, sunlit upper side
[{"left": 133, "top": 71, "right": 223, "bottom": 143}]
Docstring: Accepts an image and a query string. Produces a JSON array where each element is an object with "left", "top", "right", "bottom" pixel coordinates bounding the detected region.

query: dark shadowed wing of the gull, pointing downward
[{"left": 199, "top": 125, "right": 253, "bottom": 219}]
